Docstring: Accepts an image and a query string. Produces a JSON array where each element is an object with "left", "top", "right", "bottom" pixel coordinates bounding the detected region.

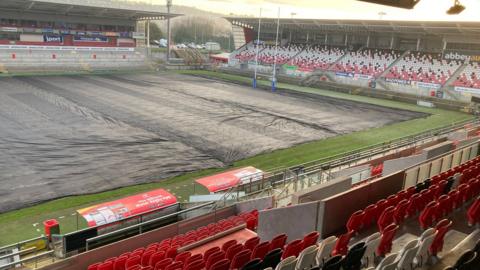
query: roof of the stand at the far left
[{"left": 0, "top": 0, "right": 181, "bottom": 20}]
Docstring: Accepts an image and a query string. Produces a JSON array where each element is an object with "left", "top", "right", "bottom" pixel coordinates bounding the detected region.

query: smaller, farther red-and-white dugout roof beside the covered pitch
[{"left": 196, "top": 166, "right": 263, "bottom": 192}]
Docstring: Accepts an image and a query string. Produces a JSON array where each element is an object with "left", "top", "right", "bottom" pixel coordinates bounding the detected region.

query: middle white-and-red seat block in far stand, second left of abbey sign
[{"left": 332, "top": 49, "right": 401, "bottom": 77}]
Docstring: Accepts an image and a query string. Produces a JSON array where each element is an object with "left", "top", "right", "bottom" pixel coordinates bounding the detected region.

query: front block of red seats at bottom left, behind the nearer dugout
[{"left": 88, "top": 210, "right": 258, "bottom": 270}]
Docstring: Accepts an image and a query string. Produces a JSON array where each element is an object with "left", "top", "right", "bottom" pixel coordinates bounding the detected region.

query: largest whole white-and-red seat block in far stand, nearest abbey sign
[{"left": 385, "top": 52, "right": 463, "bottom": 85}]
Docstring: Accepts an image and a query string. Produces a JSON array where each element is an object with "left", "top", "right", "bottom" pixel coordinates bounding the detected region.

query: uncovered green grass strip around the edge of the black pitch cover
[{"left": 0, "top": 71, "right": 473, "bottom": 246}]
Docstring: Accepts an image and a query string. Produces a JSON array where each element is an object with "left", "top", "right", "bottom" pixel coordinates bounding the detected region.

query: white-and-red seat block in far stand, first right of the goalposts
[{"left": 289, "top": 45, "right": 345, "bottom": 70}]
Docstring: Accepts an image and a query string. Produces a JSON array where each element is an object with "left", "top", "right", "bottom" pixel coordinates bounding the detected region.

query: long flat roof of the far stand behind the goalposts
[{"left": 225, "top": 17, "right": 480, "bottom": 36}]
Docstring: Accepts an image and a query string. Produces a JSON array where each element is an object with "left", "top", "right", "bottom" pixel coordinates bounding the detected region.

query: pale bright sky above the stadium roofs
[{"left": 152, "top": 0, "right": 480, "bottom": 21}]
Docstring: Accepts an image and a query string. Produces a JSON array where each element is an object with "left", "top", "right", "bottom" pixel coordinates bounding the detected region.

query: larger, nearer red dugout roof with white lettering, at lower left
[{"left": 77, "top": 189, "right": 177, "bottom": 227}]
